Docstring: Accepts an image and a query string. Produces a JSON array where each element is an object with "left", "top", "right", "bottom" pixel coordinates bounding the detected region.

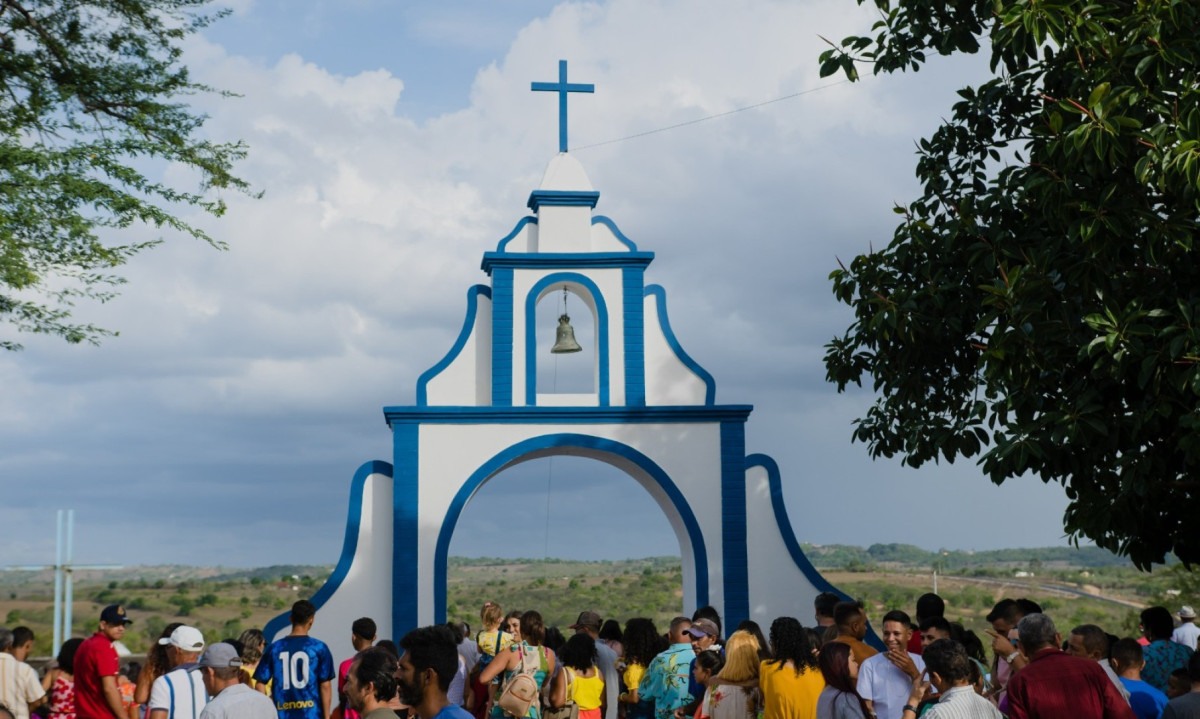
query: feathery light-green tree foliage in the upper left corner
[{"left": 0, "top": 0, "right": 248, "bottom": 349}]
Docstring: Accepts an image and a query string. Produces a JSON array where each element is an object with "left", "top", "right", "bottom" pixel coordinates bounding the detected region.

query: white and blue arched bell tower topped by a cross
[{"left": 266, "top": 61, "right": 854, "bottom": 655}]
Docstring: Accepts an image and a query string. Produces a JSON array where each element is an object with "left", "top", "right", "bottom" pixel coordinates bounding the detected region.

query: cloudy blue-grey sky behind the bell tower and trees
[{"left": 0, "top": 0, "right": 1080, "bottom": 573}]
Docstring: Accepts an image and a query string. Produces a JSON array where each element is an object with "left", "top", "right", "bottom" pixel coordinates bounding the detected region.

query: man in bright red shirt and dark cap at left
[{"left": 74, "top": 604, "right": 130, "bottom": 719}]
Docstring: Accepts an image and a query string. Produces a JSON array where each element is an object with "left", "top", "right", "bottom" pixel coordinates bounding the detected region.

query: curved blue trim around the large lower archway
[{"left": 433, "top": 433, "right": 708, "bottom": 624}]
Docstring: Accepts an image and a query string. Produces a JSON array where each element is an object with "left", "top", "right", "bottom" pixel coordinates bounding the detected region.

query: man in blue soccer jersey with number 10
[{"left": 254, "top": 599, "right": 335, "bottom": 719}]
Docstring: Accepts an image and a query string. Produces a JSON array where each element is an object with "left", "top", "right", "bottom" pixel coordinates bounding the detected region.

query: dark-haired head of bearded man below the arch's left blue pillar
[{"left": 398, "top": 625, "right": 472, "bottom": 719}]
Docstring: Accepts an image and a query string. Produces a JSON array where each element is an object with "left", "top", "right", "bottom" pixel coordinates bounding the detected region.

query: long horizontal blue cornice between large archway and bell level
[{"left": 383, "top": 405, "right": 754, "bottom": 426}]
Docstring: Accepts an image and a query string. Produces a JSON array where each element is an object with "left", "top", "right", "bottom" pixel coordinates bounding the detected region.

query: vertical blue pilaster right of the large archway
[{"left": 721, "top": 421, "right": 750, "bottom": 627}]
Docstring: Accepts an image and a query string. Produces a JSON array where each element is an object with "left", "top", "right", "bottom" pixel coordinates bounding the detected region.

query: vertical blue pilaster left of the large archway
[{"left": 391, "top": 423, "right": 421, "bottom": 639}]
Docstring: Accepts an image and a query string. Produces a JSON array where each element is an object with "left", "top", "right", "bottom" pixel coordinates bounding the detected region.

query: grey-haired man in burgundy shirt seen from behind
[{"left": 1008, "top": 613, "right": 1135, "bottom": 719}]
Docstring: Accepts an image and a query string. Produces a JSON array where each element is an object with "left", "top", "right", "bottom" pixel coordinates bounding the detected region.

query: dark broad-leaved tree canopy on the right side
[{"left": 821, "top": 0, "right": 1200, "bottom": 568}]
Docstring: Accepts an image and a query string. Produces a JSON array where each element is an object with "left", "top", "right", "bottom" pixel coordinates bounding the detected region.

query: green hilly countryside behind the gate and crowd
[{"left": 0, "top": 544, "right": 1200, "bottom": 655}]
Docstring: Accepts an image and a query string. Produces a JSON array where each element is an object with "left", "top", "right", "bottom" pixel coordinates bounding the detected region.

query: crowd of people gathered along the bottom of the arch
[{"left": 7, "top": 593, "right": 1200, "bottom": 719}]
